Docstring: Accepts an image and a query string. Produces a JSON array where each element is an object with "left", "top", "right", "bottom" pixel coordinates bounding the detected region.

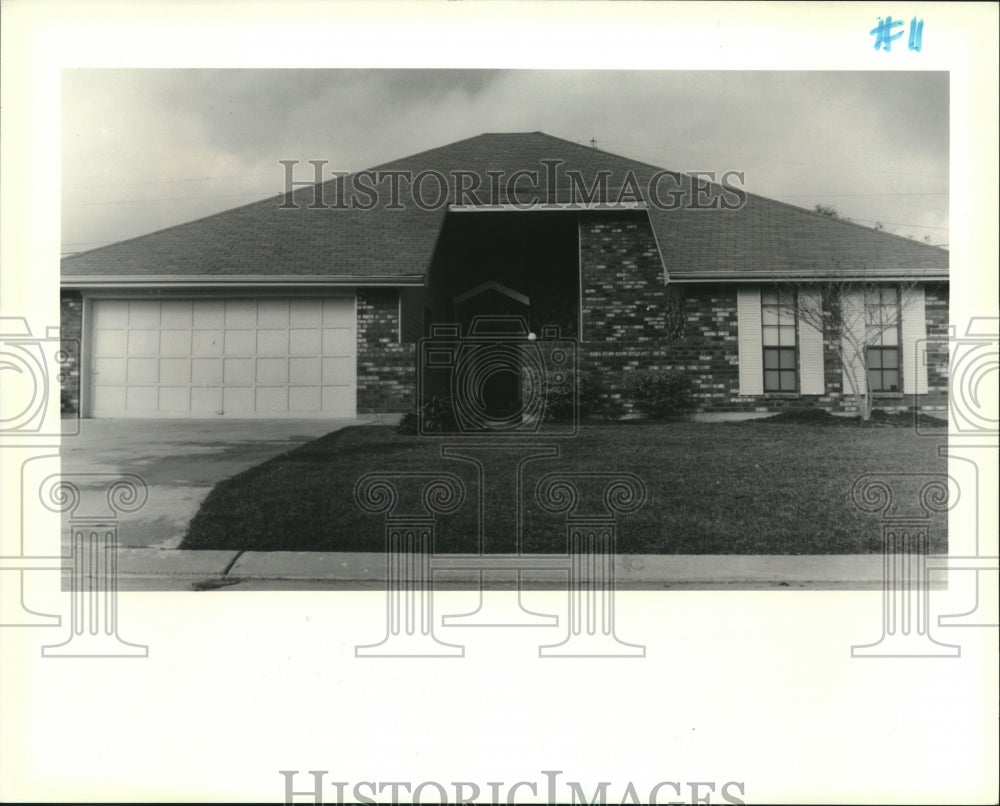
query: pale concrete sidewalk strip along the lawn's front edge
[{"left": 99, "top": 548, "right": 908, "bottom": 591}]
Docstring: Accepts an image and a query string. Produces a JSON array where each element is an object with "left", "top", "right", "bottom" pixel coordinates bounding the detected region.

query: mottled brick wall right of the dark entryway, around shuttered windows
[{"left": 580, "top": 218, "right": 948, "bottom": 414}]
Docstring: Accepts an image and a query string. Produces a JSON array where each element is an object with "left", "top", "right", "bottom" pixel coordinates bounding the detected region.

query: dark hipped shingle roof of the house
[{"left": 62, "top": 132, "right": 948, "bottom": 282}]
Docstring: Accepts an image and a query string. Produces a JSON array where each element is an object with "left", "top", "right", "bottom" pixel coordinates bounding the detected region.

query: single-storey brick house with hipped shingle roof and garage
[{"left": 62, "top": 132, "right": 948, "bottom": 417}]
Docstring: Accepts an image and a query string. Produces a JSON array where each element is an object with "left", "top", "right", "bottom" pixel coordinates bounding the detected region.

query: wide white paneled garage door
[{"left": 90, "top": 296, "right": 356, "bottom": 417}]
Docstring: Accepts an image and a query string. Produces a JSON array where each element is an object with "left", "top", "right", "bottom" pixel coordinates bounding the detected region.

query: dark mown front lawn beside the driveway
[{"left": 182, "top": 421, "right": 947, "bottom": 554}]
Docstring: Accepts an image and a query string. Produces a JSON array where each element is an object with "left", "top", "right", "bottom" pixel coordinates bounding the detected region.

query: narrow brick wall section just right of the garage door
[{"left": 358, "top": 288, "right": 417, "bottom": 414}]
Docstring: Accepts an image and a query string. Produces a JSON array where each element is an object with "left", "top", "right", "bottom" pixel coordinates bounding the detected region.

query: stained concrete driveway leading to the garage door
[{"left": 62, "top": 419, "right": 359, "bottom": 548}]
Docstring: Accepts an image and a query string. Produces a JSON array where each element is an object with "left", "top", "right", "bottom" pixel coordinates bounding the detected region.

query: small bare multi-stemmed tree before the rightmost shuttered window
[{"left": 777, "top": 278, "right": 922, "bottom": 420}]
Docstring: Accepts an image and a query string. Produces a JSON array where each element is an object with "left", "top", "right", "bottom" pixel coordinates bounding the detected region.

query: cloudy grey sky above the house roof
[{"left": 62, "top": 69, "right": 949, "bottom": 253}]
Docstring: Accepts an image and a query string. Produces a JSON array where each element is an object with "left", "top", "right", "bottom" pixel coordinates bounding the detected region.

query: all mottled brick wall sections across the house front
[{"left": 60, "top": 251, "right": 948, "bottom": 422}]
